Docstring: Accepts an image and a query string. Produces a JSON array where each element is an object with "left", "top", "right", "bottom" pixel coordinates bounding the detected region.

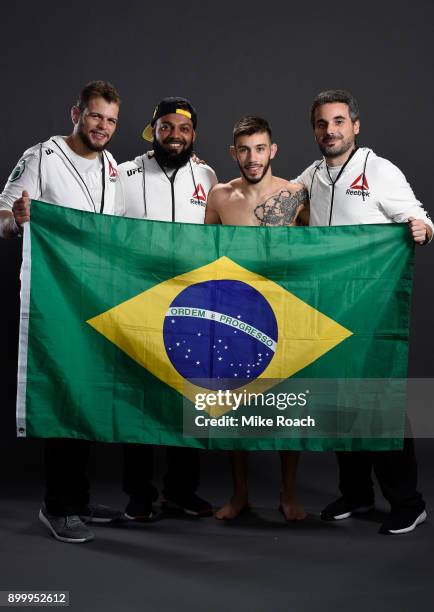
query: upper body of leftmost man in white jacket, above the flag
[{"left": 0, "top": 81, "right": 120, "bottom": 237}]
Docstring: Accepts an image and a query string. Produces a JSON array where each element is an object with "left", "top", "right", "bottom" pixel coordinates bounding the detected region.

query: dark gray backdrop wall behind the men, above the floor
[{"left": 0, "top": 0, "right": 434, "bottom": 440}]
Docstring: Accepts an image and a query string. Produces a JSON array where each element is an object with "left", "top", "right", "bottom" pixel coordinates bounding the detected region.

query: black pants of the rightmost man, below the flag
[{"left": 336, "top": 438, "right": 425, "bottom": 512}]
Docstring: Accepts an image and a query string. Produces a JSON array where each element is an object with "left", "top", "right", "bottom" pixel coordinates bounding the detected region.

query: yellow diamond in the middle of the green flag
[{"left": 87, "top": 257, "right": 352, "bottom": 416}]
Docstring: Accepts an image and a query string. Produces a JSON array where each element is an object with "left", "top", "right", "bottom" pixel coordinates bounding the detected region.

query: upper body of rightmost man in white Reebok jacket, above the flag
[{"left": 294, "top": 90, "right": 433, "bottom": 243}]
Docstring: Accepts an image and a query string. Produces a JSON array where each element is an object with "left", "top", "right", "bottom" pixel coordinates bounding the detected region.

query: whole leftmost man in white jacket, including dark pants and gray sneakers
[{"left": 0, "top": 81, "right": 120, "bottom": 542}]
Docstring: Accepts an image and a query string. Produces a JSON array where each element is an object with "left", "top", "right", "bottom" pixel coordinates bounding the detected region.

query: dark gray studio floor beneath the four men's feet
[{"left": 0, "top": 440, "right": 434, "bottom": 612}]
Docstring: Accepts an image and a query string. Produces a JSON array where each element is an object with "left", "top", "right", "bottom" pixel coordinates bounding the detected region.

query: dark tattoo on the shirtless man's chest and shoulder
[{"left": 253, "top": 189, "right": 308, "bottom": 226}]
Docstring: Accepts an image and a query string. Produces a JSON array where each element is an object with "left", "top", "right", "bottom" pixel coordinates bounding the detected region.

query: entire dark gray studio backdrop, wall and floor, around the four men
[{"left": 0, "top": 5, "right": 434, "bottom": 612}]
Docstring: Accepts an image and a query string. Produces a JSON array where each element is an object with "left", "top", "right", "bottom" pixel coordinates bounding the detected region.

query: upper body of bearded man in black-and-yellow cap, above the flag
[{"left": 116, "top": 98, "right": 217, "bottom": 223}]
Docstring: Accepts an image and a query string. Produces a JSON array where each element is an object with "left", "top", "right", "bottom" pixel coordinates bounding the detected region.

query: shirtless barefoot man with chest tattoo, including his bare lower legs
[{"left": 205, "top": 116, "right": 309, "bottom": 521}]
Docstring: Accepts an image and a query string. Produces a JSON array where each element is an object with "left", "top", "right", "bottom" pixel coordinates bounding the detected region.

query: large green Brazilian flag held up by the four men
[{"left": 17, "top": 201, "right": 413, "bottom": 450}]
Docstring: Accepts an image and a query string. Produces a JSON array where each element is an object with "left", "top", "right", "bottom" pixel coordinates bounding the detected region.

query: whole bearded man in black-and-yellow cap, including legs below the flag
[{"left": 116, "top": 97, "right": 217, "bottom": 521}]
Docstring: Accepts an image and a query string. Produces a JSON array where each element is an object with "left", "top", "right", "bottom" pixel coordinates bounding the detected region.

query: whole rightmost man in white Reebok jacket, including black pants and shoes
[{"left": 294, "top": 89, "right": 433, "bottom": 534}]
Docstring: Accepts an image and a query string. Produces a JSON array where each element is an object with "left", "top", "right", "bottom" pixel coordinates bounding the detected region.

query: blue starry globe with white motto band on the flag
[{"left": 163, "top": 280, "right": 278, "bottom": 389}]
